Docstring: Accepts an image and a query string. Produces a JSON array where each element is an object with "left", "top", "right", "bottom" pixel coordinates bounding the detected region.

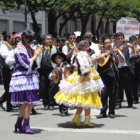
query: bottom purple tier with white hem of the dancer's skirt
[{"left": 11, "top": 90, "right": 39, "bottom": 104}]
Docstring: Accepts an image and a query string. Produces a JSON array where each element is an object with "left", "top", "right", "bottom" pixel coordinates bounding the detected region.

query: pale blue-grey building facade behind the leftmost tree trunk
[{"left": 0, "top": 8, "right": 46, "bottom": 35}]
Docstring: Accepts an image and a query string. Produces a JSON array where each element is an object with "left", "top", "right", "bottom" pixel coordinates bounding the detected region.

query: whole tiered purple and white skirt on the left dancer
[{"left": 9, "top": 71, "right": 39, "bottom": 104}]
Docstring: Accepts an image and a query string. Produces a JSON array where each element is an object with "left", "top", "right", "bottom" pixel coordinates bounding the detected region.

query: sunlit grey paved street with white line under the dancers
[{"left": 0, "top": 85, "right": 140, "bottom": 140}]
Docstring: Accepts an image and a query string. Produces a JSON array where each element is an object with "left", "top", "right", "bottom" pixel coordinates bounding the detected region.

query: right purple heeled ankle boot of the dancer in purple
[{"left": 22, "top": 118, "right": 34, "bottom": 134}]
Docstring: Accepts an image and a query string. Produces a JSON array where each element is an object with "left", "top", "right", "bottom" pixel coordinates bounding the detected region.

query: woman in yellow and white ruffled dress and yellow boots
[{"left": 55, "top": 41, "right": 103, "bottom": 127}]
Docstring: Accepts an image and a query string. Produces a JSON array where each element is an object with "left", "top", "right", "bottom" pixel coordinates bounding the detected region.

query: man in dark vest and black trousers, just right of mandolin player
[{"left": 115, "top": 32, "right": 133, "bottom": 109}]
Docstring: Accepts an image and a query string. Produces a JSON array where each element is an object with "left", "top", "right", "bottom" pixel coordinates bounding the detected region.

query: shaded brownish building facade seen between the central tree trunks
[{"left": 56, "top": 15, "right": 115, "bottom": 35}]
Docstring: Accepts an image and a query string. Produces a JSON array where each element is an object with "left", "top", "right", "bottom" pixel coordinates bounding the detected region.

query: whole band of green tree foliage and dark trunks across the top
[{"left": 0, "top": 0, "right": 140, "bottom": 34}]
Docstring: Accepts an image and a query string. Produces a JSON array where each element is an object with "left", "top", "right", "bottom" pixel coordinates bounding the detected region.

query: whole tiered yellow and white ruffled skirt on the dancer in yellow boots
[{"left": 54, "top": 67, "right": 104, "bottom": 109}]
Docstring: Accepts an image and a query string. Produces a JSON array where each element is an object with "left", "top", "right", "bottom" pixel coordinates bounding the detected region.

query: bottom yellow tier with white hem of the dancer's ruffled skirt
[{"left": 54, "top": 91, "right": 102, "bottom": 109}]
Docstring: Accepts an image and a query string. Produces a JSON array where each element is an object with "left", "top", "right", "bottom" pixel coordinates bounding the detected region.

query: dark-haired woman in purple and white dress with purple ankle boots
[{"left": 10, "top": 31, "right": 42, "bottom": 134}]
